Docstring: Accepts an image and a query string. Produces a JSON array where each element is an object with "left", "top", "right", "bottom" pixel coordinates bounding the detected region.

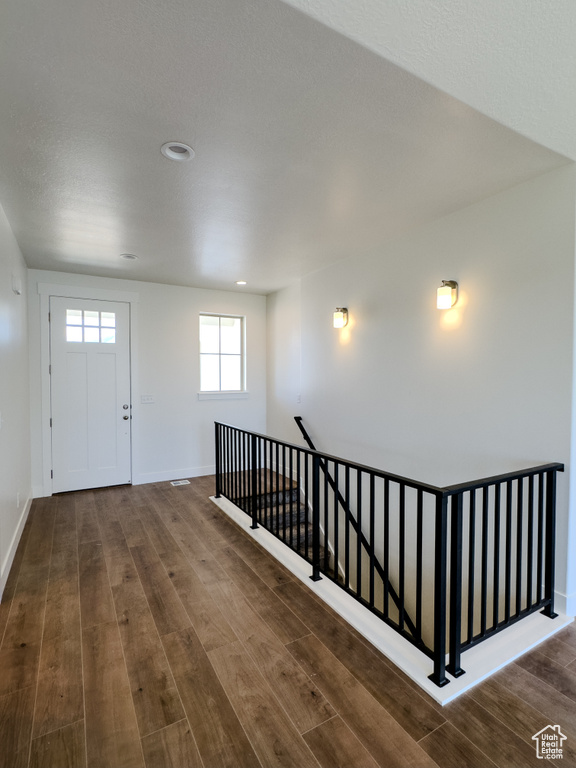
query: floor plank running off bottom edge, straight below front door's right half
[{"left": 82, "top": 621, "right": 144, "bottom": 768}]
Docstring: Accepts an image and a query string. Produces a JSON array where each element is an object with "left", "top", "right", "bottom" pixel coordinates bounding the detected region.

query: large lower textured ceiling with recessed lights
[{"left": 0, "top": 0, "right": 566, "bottom": 293}]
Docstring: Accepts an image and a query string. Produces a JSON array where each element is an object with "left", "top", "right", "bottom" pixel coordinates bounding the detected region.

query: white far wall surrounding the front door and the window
[{"left": 29, "top": 270, "right": 266, "bottom": 495}]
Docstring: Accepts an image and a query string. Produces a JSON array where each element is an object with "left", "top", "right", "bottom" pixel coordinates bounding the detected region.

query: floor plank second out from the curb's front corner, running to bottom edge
[{"left": 287, "top": 635, "right": 434, "bottom": 768}]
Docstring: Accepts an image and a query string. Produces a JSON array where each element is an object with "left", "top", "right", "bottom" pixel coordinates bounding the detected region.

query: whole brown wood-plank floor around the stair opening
[{"left": 0, "top": 478, "right": 576, "bottom": 768}]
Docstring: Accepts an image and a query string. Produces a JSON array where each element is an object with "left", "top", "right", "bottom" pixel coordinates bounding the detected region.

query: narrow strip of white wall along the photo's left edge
[{"left": 0, "top": 202, "right": 32, "bottom": 596}]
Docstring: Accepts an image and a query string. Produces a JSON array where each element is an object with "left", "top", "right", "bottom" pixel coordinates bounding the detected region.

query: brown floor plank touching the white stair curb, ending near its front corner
[{"left": 275, "top": 582, "right": 446, "bottom": 741}]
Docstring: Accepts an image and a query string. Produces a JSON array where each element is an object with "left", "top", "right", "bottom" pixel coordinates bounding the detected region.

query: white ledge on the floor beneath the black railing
[{"left": 211, "top": 497, "right": 573, "bottom": 705}]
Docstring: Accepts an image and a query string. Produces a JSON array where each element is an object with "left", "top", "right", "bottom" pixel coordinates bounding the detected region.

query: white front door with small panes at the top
[{"left": 50, "top": 296, "right": 131, "bottom": 493}]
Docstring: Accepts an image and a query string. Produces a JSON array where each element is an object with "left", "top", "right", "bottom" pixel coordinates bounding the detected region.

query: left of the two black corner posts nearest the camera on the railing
[{"left": 429, "top": 494, "right": 450, "bottom": 687}]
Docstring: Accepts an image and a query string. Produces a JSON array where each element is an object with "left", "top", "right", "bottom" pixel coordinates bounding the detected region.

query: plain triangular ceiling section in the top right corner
[{"left": 285, "top": 0, "right": 576, "bottom": 160}]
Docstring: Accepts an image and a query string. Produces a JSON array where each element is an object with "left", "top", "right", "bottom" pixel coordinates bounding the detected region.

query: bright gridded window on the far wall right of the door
[{"left": 200, "top": 315, "right": 245, "bottom": 392}]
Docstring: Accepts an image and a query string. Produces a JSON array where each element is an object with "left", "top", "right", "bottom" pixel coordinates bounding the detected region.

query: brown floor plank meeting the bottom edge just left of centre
[{"left": 162, "top": 628, "right": 260, "bottom": 768}]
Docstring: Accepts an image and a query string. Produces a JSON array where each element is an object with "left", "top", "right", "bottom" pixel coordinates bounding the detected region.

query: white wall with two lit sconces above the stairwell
[{"left": 268, "top": 167, "right": 576, "bottom": 612}]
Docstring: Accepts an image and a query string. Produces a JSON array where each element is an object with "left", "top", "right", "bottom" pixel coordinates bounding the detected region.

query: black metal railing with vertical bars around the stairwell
[{"left": 215, "top": 422, "right": 564, "bottom": 686}]
